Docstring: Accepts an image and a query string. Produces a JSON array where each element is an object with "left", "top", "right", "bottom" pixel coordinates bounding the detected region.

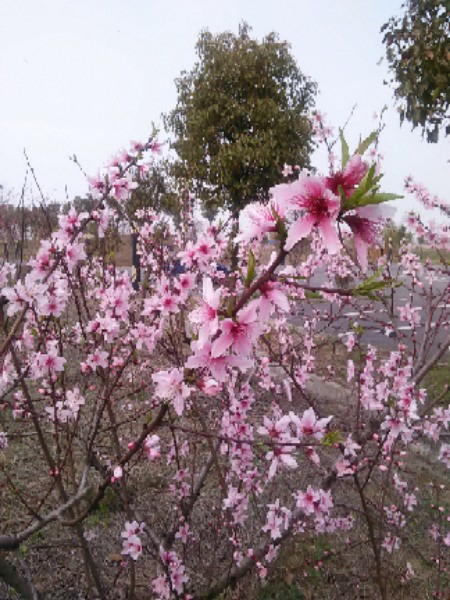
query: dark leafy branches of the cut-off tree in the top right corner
[{"left": 381, "top": 0, "right": 450, "bottom": 142}]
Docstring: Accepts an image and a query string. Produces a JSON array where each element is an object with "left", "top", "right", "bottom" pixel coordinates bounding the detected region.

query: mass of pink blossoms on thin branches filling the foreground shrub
[{"left": 0, "top": 131, "right": 450, "bottom": 600}]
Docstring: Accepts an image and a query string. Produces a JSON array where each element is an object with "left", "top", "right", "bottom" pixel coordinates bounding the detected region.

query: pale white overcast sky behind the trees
[{"left": 0, "top": 0, "right": 450, "bottom": 220}]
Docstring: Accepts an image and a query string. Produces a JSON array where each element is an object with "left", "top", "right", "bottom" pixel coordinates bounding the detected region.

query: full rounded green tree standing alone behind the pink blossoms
[{"left": 165, "top": 23, "right": 316, "bottom": 216}]
